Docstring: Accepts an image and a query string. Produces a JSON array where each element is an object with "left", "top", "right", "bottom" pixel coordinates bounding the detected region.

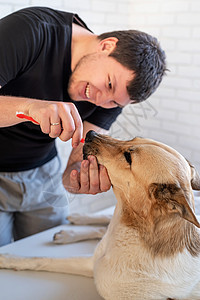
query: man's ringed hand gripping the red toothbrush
[{"left": 27, "top": 100, "right": 83, "bottom": 147}]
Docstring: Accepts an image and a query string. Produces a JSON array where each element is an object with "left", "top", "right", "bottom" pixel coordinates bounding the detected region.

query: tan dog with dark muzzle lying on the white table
[{"left": 0, "top": 131, "right": 200, "bottom": 300}]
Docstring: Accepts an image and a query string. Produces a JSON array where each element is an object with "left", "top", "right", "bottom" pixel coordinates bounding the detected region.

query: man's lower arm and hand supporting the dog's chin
[{"left": 63, "top": 121, "right": 111, "bottom": 195}]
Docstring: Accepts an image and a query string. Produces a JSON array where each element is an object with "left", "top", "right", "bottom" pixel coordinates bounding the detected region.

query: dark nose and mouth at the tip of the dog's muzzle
[{"left": 83, "top": 130, "right": 98, "bottom": 159}]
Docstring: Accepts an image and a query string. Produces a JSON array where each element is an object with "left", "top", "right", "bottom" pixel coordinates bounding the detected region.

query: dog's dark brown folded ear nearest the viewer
[{"left": 149, "top": 183, "right": 200, "bottom": 228}]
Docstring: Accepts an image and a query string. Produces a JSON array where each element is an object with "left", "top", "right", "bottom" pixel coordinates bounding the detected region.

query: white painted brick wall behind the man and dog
[{"left": 0, "top": 0, "right": 200, "bottom": 211}]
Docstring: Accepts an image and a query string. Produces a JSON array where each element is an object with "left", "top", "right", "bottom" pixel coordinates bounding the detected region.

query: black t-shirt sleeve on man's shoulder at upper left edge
[{"left": 0, "top": 10, "right": 41, "bottom": 87}]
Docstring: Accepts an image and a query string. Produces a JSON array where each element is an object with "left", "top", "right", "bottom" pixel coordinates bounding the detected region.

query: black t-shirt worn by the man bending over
[{"left": 0, "top": 7, "right": 121, "bottom": 172}]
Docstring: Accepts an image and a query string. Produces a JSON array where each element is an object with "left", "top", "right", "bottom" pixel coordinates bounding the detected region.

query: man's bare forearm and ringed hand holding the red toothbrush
[{"left": 0, "top": 96, "right": 83, "bottom": 147}]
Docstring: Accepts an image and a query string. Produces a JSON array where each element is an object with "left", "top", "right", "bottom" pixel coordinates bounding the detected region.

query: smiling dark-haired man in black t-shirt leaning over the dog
[{"left": 0, "top": 7, "right": 166, "bottom": 245}]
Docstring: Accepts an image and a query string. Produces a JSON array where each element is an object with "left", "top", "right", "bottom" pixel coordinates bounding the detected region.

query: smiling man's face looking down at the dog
[{"left": 68, "top": 53, "right": 134, "bottom": 108}]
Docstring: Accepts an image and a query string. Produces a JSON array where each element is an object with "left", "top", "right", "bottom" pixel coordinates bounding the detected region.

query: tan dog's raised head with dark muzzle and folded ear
[{"left": 83, "top": 131, "right": 200, "bottom": 227}]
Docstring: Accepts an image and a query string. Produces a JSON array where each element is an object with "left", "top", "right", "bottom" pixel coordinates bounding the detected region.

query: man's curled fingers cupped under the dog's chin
[{"left": 63, "top": 155, "right": 111, "bottom": 195}]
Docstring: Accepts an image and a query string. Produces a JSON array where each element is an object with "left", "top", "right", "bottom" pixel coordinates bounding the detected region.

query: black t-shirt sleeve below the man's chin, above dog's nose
[{"left": 85, "top": 106, "right": 122, "bottom": 130}]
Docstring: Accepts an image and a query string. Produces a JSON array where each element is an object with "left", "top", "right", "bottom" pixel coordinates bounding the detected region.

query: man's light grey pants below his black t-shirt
[{"left": 0, "top": 157, "right": 68, "bottom": 246}]
